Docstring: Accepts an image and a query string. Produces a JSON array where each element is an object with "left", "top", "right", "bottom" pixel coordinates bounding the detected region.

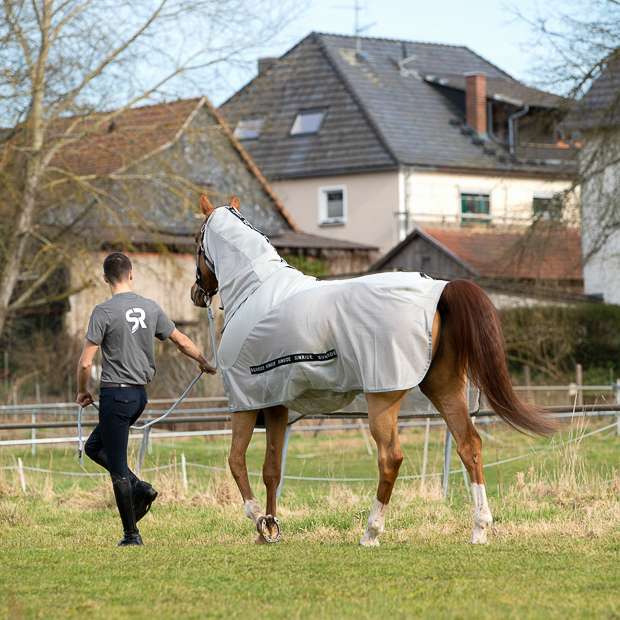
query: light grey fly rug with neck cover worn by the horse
[{"left": 202, "top": 207, "right": 447, "bottom": 414}]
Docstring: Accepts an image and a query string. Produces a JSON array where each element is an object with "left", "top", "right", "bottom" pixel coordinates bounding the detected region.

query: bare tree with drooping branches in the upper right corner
[{"left": 512, "top": 0, "right": 620, "bottom": 264}]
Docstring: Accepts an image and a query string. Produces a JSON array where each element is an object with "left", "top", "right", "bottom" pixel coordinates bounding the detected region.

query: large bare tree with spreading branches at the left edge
[{"left": 0, "top": 0, "right": 296, "bottom": 334}]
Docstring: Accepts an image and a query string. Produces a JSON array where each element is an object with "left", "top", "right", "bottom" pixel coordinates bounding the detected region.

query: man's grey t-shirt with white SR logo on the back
[{"left": 86, "top": 292, "right": 174, "bottom": 385}]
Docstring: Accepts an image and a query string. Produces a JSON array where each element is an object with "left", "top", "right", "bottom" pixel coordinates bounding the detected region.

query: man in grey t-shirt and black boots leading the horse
[{"left": 76, "top": 252, "right": 215, "bottom": 546}]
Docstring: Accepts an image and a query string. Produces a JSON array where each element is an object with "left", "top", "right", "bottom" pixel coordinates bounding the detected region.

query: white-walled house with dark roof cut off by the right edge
[{"left": 564, "top": 63, "right": 620, "bottom": 304}]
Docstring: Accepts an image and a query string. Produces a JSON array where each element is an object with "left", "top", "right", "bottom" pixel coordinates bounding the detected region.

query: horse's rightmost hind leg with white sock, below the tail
[{"left": 420, "top": 356, "right": 493, "bottom": 544}]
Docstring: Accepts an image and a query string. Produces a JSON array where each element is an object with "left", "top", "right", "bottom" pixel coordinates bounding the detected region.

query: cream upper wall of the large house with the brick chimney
[{"left": 272, "top": 168, "right": 570, "bottom": 254}]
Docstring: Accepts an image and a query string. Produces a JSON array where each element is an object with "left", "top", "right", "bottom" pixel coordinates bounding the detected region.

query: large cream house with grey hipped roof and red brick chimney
[{"left": 220, "top": 33, "right": 578, "bottom": 252}]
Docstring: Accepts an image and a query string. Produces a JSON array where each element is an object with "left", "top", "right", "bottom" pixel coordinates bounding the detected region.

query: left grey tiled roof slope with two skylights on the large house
[{"left": 220, "top": 36, "right": 396, "bottom": 178}]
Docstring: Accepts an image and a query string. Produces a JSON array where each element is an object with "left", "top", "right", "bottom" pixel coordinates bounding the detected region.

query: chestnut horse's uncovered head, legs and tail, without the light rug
[{"left": 191, "top": 196, "right": 555, "bottom": 547}]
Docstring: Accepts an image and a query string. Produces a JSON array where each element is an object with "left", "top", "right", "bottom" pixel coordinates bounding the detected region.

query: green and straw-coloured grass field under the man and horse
[{"left": 0, "top": 421, "right": 620, "bottom": 619}]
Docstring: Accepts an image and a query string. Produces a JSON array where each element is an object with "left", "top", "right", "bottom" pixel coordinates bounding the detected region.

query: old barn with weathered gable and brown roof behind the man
[{"left": 54, "top": 97, "right": 377, "bottom": 335}]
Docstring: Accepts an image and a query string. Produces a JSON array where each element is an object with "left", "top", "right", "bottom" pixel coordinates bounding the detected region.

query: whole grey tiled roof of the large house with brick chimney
[{"left": 221, "top": 33, "right": 575, "bottom": 178}]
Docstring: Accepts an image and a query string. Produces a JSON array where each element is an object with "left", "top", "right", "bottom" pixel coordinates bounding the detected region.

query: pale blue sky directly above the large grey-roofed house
[{"left": 210, "top": 0, "right": 549, "bottom": 105}]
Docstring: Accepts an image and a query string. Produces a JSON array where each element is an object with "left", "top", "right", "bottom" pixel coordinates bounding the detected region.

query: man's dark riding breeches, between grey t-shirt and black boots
[{"left": 84, "top": 387, "right": 147, "bottom": 478}]
